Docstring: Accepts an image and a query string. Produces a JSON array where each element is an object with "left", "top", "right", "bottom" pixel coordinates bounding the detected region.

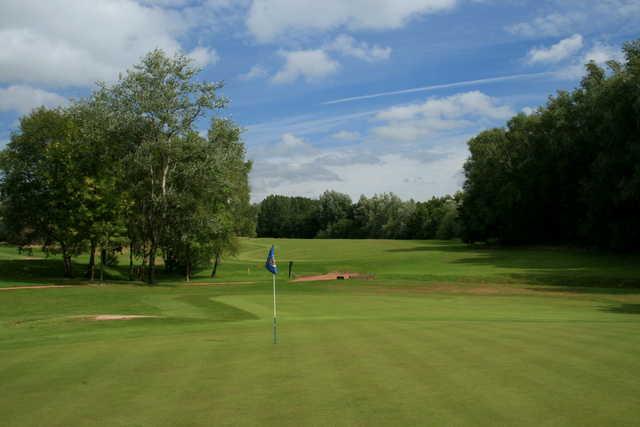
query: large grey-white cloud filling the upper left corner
[{"left": 0, "top": 0, "right": 217, "bottom": 86}]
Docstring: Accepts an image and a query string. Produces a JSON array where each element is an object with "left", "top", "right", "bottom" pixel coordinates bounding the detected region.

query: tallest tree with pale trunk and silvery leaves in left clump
[{"left": 96, "top": 50, "right": 227, "bottom": 283}]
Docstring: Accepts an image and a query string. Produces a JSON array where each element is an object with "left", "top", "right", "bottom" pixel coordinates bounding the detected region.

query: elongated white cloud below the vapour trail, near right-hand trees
[{"left": 373, "top": 91, "right": 514, "bottom": 142}]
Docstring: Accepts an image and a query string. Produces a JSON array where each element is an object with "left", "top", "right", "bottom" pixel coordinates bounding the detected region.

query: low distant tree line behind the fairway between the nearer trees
[{"left": 256, "top": 191, "right": 461, "bottom": 239}]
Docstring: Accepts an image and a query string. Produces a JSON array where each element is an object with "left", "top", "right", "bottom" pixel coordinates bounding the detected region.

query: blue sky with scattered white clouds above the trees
[{"left": 0, "top": 0, "right": 640, "bottom": 202}]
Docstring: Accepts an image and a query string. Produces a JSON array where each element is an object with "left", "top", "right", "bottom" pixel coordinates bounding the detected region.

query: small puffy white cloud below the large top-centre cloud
[{"left": 272, "top": 49, "right": 340, "bottom": 83}]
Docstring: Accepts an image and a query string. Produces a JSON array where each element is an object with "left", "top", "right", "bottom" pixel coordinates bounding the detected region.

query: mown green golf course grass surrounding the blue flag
[{"left": 0, "top": 239, "right": 640, "bottom": 426}]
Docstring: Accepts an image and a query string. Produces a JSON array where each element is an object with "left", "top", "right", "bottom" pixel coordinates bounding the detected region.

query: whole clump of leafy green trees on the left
[{"left": 0, "top": 50, "right": 255, "bottom": 283}]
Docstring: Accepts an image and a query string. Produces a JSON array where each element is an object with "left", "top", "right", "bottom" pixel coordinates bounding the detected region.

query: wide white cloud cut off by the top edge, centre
[{"left": 247, "top": 0, "right": 456, "bottom": 42}]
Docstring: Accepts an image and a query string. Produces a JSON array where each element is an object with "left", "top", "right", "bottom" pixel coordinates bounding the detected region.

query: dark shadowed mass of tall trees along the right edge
[{"left": 460, "top": 40, "right": 640, "bottom": 250}]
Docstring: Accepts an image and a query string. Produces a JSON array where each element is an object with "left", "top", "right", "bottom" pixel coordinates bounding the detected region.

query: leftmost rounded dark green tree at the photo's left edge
[{"left": 0, "top": 108, "right": 91, "bottom": 277}]
